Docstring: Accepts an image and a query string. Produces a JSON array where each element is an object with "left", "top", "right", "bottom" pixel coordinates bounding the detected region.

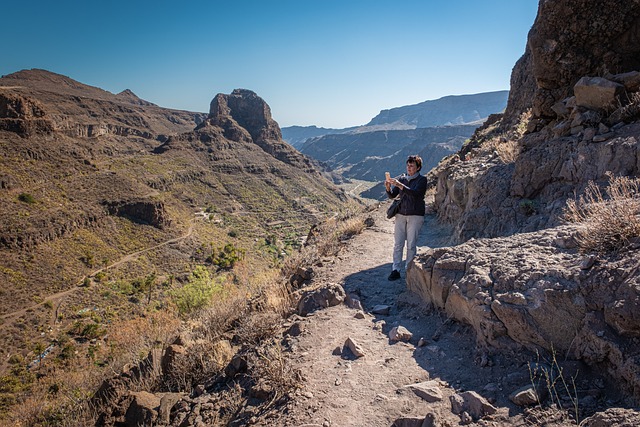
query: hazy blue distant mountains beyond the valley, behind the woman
[{"left": 282, "top": 90, "right": 509, "bottom": 198}]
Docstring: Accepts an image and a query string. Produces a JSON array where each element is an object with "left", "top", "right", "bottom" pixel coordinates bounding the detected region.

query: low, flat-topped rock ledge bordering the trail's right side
[{"left": 407, "top": 226, "right": 640, "bottom": 398}]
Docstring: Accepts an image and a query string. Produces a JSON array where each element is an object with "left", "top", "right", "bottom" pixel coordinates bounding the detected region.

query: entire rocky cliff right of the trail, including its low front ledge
[{"left": 408, "top": 0, "right": 640, "bottom": 399}]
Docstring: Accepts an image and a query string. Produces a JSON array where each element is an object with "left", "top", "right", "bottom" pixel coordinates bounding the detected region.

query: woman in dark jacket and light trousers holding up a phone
[{"left": 384, "top": 155, "right": 427, "bottom": 280}]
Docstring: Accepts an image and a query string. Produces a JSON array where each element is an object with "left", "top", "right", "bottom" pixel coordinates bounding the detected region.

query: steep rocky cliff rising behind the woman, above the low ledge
[{"left": 432, "top": 0, "right": 640, "bottom": 241}]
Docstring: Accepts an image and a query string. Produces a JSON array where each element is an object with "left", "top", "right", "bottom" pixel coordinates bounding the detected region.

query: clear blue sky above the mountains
[{"left": 0, "top": 0, "right": 538, "bottom": 128}]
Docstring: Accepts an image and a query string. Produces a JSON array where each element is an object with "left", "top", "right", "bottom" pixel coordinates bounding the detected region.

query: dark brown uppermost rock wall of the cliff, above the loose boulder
[{"left": 528, "top": 0, "right": 640, "bottom": 118}]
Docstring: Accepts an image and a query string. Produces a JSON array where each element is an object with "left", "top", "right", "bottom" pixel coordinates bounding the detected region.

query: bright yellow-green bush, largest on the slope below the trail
[{"left": 170, "top": 266, "right": 222, "bottom": 315}]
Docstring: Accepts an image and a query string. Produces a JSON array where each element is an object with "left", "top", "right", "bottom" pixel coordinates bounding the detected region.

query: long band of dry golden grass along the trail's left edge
[{"left": 0, "top": 206, "right": 366, "bottom": 426}]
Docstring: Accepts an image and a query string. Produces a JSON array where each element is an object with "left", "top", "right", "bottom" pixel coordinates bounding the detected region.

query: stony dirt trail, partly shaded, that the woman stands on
[{"left": 260, "top": 205, "right": 564, "bottom": 427}]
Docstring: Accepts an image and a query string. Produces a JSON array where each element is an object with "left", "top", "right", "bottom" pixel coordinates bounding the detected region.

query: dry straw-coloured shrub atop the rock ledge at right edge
[{"left": 564, "top": 174, "right": 640, "bottom": 253}]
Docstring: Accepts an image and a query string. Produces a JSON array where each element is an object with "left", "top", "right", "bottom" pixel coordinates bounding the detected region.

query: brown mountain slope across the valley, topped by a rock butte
[{"left": 0, "top": 70, "right": 352, "bottom": 378}]
